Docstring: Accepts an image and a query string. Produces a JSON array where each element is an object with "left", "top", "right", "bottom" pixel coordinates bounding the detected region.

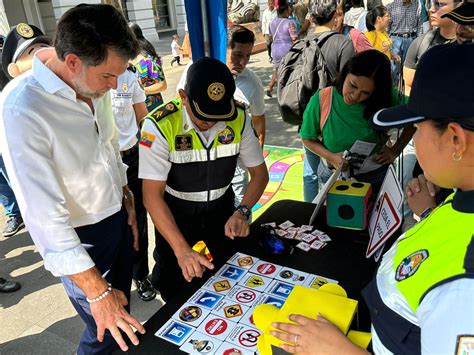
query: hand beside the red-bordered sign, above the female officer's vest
[{"left": 406, "top": 175, "right": 440, "bottom": 216}]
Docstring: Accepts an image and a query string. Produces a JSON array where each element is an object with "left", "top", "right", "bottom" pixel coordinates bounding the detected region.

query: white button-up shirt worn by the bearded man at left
[{"left": 0, "top": 49, "right": 127, "bottom": 276}]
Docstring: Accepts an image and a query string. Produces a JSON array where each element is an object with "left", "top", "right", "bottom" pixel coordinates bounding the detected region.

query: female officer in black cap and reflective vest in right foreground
[{"left": 273, "top": 45, "right": 474, "bottom": 354}]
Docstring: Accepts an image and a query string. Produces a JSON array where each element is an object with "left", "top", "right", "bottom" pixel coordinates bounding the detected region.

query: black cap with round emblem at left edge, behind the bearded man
[{"left": 2, "top": 23, "right": 52, "bottom": 77}]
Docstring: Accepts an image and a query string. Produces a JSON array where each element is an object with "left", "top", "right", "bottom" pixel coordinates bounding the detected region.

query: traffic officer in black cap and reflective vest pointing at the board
[{"left": 139, "top": 58, "right": 268, "bottom": 300}]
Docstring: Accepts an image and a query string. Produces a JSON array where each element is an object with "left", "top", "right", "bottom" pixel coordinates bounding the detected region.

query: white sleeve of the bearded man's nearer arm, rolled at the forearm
[{"left": 0, "top": 106, "right": 94, "bottom": 276}]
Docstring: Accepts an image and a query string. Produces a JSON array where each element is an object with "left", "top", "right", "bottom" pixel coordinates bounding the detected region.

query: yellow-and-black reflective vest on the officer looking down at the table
[{"left": 147, "top": 99, "right": 245, "bottom": 202}]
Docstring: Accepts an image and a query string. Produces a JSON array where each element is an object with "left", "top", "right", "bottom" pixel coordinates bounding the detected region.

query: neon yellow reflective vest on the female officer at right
[{"left": 363, "top": 195, "right": 474, "bottom": 354}]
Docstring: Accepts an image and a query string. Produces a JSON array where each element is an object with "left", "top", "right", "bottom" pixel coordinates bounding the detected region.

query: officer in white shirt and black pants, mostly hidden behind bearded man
[{"left": 111, "top": 64, "right": 156, "bottom": 301}]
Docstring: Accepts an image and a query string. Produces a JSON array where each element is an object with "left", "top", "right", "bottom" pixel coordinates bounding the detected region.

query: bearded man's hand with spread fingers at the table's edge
[{"left": 90, "top": 288, "right": 145, "bottom": 351}]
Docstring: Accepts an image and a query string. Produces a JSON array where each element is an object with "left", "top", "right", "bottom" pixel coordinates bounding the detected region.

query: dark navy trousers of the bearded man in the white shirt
[{"left": 61, "top": 211, "right": 133, "bottom": 355}]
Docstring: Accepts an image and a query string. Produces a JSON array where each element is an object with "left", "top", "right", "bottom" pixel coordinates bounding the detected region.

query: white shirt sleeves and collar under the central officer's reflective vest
[{"left": 138, "top": 107, "right": 264, "bottom": 181}]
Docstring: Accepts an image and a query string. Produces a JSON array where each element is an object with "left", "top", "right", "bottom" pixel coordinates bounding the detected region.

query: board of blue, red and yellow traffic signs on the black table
[{"left": 155, "top": 253, "right": 337, "bottom": 355}]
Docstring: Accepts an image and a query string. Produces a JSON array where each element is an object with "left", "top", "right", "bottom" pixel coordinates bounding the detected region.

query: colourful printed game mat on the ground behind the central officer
[{"left": 252, "top": 145, "right": 304, "bottom": 220}]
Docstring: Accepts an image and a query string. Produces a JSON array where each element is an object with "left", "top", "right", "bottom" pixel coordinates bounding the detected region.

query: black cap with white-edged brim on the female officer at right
[{"left": 371, "top": 43, "right": 474, "bottom": 130}]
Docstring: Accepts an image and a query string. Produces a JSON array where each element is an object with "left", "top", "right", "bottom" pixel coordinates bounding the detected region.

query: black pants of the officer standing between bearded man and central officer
[{"left": 122, "top": 145, "right": 150, "bottom": 280}]
